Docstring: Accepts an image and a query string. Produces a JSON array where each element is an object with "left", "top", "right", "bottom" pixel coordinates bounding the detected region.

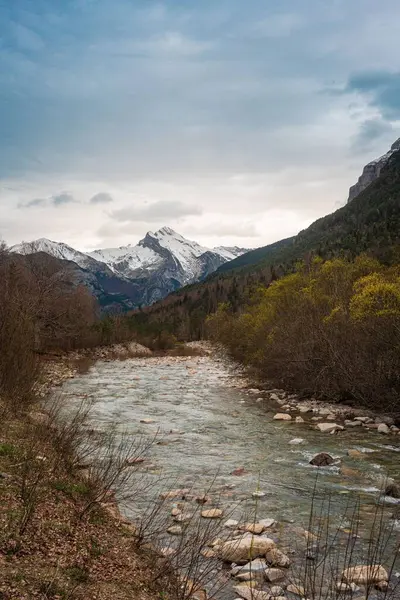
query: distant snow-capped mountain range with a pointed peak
[{"left": 11, "top": 227, "right": 247, "bottom": 309}]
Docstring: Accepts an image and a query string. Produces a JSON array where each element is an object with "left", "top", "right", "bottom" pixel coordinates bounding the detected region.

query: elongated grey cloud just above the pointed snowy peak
[{"left": 111, "top": 200, "right": 203, "bottom": 222}]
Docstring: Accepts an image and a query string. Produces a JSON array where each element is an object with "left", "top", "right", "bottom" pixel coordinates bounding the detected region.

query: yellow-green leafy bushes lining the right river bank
[{"left": 207, "top": 256, "right": 400, "bottom": 413}]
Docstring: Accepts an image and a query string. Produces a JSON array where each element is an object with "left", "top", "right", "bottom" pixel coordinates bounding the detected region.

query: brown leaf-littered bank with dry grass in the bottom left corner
[{"left": 0, "top": 404, "right": 175, "bottom": 600}]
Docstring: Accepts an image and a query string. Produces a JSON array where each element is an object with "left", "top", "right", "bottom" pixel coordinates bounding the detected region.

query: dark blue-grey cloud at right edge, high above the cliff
[{"left": 345, "top": 71, "right": 400, "bottom": 120}]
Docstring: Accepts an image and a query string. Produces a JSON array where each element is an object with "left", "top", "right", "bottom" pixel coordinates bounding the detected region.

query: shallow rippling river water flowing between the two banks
[{"left": 62, "top": 357, "right": 400, "bottom": 592}]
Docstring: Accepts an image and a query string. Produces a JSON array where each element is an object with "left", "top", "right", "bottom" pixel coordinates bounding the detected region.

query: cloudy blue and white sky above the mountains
[{"left": 0, "top": 0, "right": 400, "bottom": 249}]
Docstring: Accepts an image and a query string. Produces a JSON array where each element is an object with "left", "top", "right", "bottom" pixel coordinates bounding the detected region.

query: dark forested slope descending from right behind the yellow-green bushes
[{"left": 133, "top": 152, "right": 400, "bottom": 339}]
